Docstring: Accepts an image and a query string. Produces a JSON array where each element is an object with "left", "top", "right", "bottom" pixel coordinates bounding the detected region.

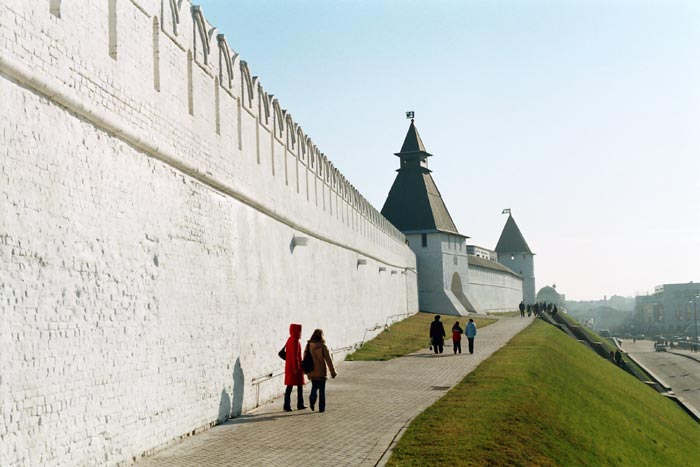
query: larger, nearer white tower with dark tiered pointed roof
[{"left": 382, "top": 120, "right": 476, "bottom": 315}]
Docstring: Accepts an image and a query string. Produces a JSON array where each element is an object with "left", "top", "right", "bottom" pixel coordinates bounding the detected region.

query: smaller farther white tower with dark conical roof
[{"left": 496, "top": 209, "right": 535, "bottom": 303}]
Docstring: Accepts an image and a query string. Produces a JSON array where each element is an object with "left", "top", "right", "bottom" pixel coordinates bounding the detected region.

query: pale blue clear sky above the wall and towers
[{"left": 195, "top": 0, "right": 700, "bottom": 299}]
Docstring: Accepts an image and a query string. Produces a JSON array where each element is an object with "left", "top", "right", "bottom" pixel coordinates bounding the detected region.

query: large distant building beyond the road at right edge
[{"left": 634, "top": 282, "right": 700, "bottom": 335}]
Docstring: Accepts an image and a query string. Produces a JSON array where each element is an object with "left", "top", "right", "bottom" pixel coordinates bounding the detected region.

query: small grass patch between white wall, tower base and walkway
[{"left": 346, "top": 312, "right": 495, "bottom": 361}]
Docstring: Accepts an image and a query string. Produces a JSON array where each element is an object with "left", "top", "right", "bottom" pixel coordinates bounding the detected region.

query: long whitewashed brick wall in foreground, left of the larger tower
[{"left": 0, "top": 0, "right": 418, "bottom": 465}]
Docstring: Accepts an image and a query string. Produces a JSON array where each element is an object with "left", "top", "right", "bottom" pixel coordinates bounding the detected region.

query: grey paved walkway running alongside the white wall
[{"left": 137, "top": 317, "right": 532, "bottom": 467}]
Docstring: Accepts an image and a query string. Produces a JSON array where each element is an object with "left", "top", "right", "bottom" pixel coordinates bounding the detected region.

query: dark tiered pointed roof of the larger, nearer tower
[{"left": 382, "top": 121, "right": 464, "bottom": 236}]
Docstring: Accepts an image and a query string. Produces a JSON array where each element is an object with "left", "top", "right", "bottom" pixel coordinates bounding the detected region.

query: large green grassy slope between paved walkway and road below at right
[{"left": 388, "top": 320, "right": 700, "bottom": 467}]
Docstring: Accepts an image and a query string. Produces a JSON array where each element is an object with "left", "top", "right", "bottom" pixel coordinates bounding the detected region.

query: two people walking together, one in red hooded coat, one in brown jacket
[{"left": 279, "top": 324, "right": 338, "bottom": 412}]
